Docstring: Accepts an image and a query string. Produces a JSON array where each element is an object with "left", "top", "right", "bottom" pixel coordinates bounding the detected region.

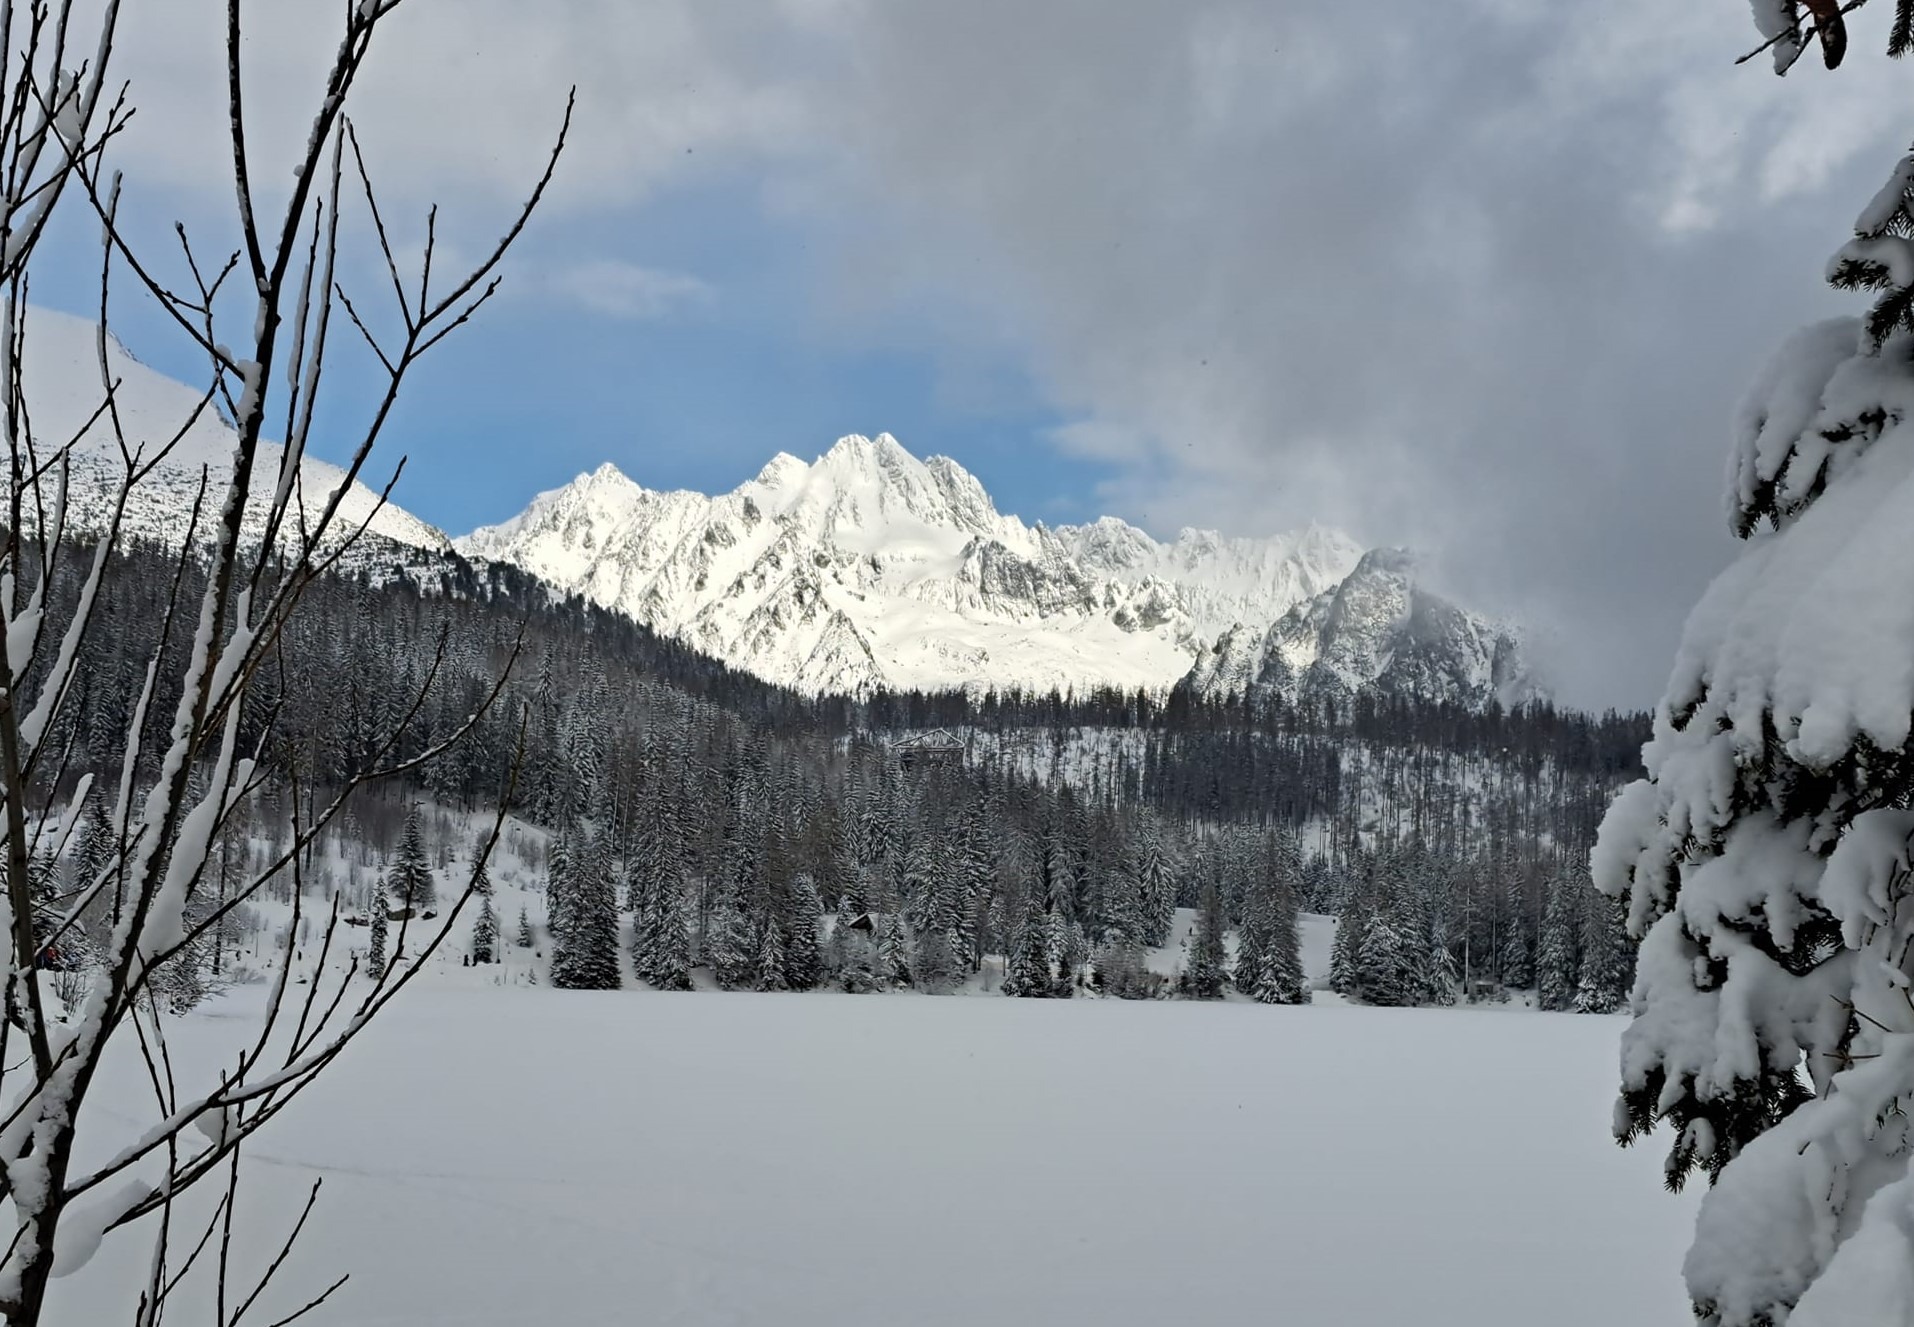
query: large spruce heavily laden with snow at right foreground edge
[{"left": 1591, "top": 111, "right": 1914, "bottom": 1327}]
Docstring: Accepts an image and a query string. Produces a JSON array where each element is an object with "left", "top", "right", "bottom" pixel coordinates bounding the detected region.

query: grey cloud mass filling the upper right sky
[{"left": 74, "top": 0, "right": 1914, "bottom": 705}]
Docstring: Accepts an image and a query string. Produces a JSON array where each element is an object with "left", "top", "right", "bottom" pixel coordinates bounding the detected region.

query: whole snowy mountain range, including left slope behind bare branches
[{"left": 23, "top": 310, "right": 1533, "bottom": 705}]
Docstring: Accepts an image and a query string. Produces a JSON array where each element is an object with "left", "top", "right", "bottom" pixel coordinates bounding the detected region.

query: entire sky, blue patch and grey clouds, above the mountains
[{"left": 36, "top": 0, "right": 1908, "bottom": 705}]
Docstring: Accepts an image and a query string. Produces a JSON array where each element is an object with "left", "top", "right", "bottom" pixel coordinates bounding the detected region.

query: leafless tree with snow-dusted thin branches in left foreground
[{"left": 0, "top": 0, "right": 572, "bottom": 1327}]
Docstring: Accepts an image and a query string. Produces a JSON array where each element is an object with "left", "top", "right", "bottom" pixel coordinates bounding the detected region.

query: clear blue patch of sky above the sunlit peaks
[{"left": 36, "top": 169, "right": 1112, "bottom": 534}]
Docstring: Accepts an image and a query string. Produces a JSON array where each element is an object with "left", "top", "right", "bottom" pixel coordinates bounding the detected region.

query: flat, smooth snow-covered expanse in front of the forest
[{"left": 50, "top": 988, "right": 1694, "bottom": 1327}]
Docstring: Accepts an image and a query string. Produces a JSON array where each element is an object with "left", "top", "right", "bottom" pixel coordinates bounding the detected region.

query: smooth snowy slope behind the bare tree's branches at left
[{"left": 21, "top": 308, "right": 450, "bottom": 550}]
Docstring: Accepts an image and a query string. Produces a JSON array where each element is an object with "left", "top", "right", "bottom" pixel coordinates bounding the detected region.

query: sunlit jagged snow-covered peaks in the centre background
[{"left": 457, "top": 435, "right": 1512, "bottom": 701}]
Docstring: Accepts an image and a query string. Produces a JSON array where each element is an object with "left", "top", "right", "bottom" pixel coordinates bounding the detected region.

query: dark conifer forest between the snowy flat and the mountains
[{"left": 29, "top": 532, "right": 1640, "bottom": 1003}]
